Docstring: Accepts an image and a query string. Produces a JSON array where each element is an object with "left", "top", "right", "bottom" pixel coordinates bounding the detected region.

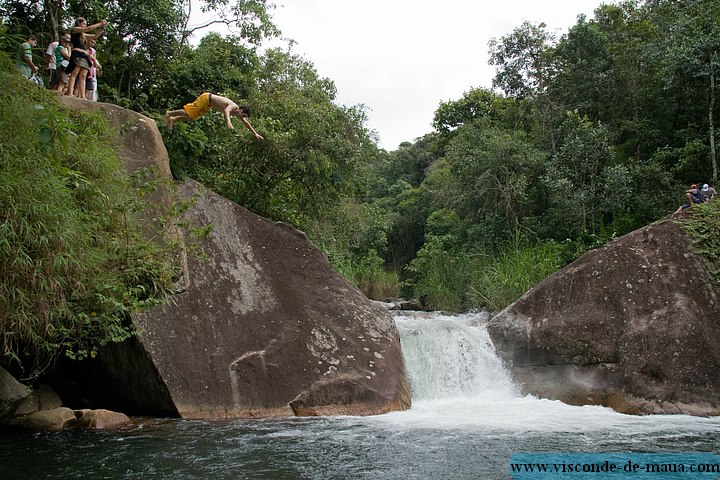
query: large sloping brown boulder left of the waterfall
[{"left": 99, "top": 181, "right": 410, "bottom": 418}]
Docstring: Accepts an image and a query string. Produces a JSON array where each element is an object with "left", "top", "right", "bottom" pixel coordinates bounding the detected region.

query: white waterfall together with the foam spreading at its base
[{"left": 386, "top": 312, "right": 718, "bottom": 438}]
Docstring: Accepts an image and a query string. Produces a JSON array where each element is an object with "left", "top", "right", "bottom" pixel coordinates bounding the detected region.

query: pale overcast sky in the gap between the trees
[{"left": 194, "top": 0, "right": 611, "bottom": 150}]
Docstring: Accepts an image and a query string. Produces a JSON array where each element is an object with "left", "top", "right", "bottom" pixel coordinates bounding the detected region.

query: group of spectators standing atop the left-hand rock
[{"left": 16, "top": 17, "right": 107, "bottom": 101}]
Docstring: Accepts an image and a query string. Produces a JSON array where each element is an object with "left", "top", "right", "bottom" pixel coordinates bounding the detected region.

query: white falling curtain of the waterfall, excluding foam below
[{"left": 395, "top": 313, "right": 517, "bottom": 401}]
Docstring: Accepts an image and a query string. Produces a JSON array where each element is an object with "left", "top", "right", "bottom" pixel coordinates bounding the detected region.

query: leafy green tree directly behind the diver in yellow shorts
[{"left": 159, "top": 42, "right": 377, "bottom": 232}]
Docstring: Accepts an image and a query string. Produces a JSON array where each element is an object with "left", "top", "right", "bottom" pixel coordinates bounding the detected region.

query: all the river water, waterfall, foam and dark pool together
[{"left": 0, "top": 313, "right": 720, "bottom": 480}]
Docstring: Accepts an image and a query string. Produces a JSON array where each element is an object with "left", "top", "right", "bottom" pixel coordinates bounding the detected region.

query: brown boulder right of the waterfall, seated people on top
[{"left": 488, "top": 220, "right": 720, "bottom": 415}]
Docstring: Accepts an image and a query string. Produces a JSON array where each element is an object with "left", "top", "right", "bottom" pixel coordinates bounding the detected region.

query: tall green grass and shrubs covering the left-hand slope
[{"left": 0, "top": 54, "right": 179, "bottom": 376}]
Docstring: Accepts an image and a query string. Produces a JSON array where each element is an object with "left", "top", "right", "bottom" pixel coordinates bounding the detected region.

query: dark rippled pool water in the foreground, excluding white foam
[{"left": 0, "top": 415, "right": 720, "bottom": 479}]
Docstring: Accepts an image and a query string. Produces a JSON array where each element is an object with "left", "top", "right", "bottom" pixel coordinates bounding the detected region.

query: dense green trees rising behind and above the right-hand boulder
[{"left": 372, "top": 0, "right": 720, "bottom": 309}]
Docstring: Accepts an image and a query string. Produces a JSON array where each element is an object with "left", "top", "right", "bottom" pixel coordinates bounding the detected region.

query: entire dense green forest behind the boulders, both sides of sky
[{"left": 0, "top": 0, "right": 720, "bottom": 374}]
